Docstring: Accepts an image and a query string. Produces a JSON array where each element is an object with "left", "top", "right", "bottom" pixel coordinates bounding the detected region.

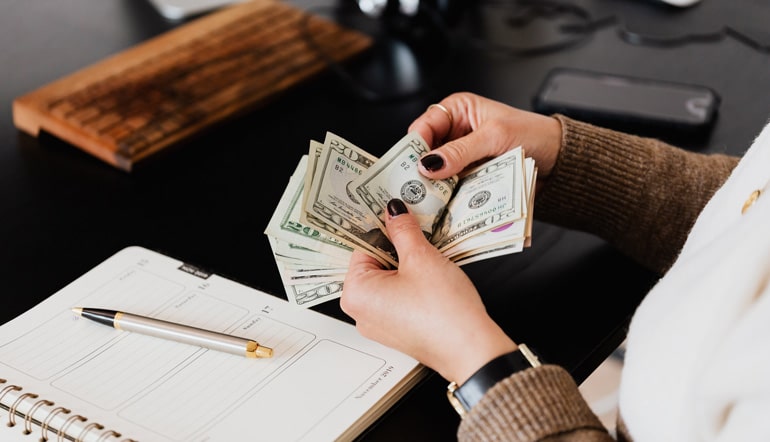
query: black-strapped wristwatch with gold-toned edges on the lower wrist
[{"left": 446, "top": 344, "right": 542, "bottom": 418}]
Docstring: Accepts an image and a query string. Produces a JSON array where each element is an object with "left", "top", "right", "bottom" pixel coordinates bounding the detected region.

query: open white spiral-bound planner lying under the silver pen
[{"left": 0, "top": 246, "right": 427, "bottom": 442}]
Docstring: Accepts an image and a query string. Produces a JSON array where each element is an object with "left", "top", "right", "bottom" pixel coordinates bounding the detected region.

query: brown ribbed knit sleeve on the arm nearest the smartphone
[{"left": 534, "top": 115, "right": 739, "bottom": 273}]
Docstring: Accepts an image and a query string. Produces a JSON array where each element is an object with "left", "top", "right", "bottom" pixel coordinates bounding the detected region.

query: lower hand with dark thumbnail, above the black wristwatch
[{"left": 340, "top": 200, "right": 517, "bottom": 384}]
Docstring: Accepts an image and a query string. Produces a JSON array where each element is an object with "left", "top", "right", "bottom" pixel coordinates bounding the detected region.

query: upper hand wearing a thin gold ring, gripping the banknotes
[{"left": 409, "top": 92, "right": 562, "bottom": 185}]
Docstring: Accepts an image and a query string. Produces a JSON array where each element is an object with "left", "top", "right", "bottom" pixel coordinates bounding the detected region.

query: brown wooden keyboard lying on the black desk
[{"left": 13, "top": 0, "right": 372, "bottom": 171}]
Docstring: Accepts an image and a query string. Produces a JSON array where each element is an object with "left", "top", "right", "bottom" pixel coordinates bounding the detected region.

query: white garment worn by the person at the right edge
[{"left": 619, "top": 119, "right": 770, "bottom": 442}]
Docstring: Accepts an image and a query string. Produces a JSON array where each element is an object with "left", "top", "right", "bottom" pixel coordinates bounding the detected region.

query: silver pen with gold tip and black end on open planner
[{"left": 72, "top": 307, "right": 273, "bottom": 358}]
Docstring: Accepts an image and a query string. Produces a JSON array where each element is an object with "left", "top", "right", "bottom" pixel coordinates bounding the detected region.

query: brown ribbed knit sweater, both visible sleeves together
[{"left": 457, "top": 115, "right": 739, "bottom": 442}]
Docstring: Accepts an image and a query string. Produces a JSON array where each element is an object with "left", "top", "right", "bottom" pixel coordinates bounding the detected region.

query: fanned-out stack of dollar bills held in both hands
[{"left": 264, "top": 132, "right": 537, "bottom": 307}]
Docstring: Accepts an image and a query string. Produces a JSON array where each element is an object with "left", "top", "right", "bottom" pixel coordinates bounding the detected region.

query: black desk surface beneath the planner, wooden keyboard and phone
[{"left": 0, "top": 0, "right": 770, "bottom": 440}]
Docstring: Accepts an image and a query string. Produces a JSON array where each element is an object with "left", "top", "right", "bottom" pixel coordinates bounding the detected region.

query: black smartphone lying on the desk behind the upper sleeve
[{"left": 533, "top": 68, "right": 720, "bottom": 142}]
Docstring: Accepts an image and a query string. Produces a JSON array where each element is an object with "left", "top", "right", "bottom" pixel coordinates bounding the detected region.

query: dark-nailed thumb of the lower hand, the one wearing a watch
[{"left": 385, "top": 198, "right": 437, "bottom": 267}]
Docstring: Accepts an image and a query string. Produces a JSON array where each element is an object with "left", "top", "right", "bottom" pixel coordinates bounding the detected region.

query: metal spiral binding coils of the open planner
[{"left": 0, "top": 378, "right": 137, "bottom": 442}]
